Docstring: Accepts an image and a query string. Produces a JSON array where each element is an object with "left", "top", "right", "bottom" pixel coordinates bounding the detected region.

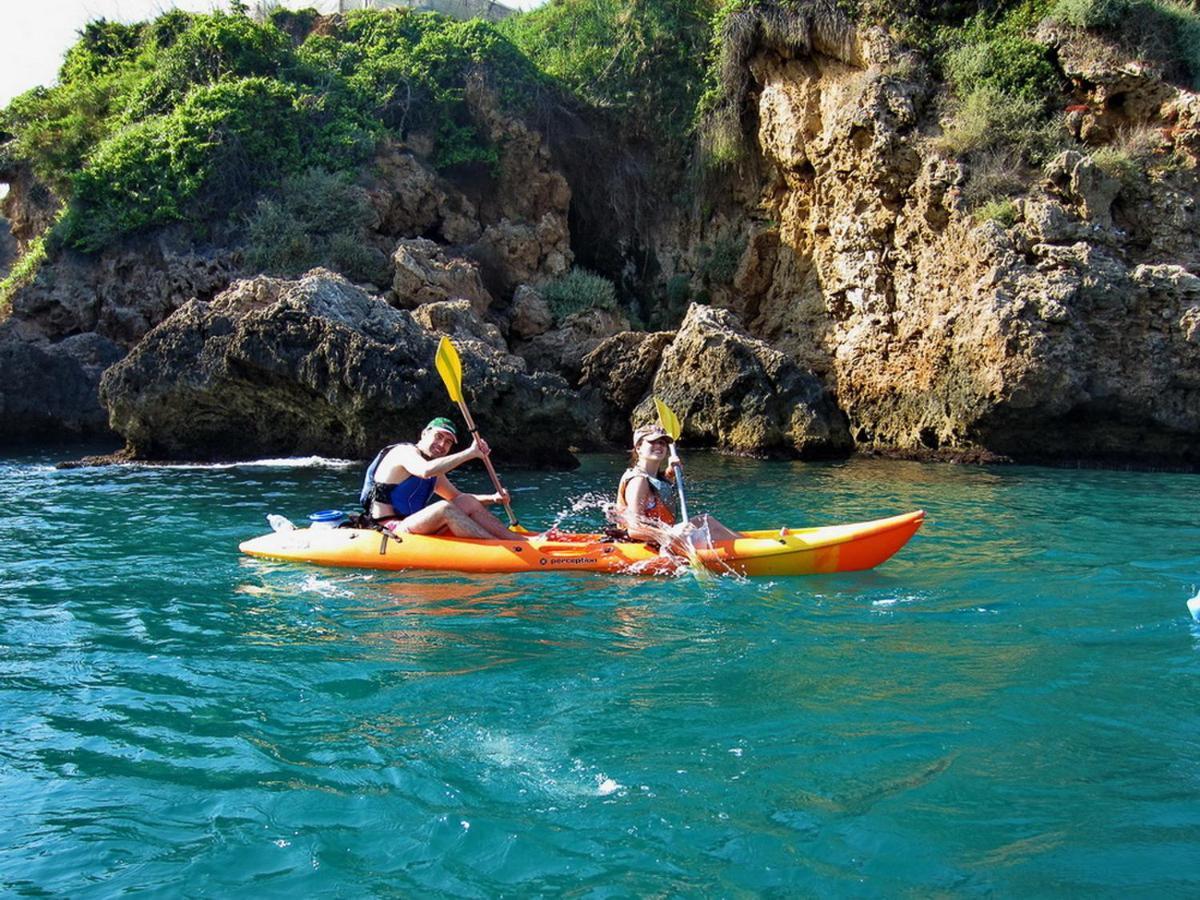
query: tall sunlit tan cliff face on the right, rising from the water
[{"left": 681, "top": 19, "right": 1200, "bottom": 466}]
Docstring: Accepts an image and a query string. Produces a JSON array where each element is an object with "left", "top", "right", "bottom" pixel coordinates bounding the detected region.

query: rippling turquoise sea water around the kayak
[{"left": 0, "top": 455, "right": 1200, "bottom": 898}]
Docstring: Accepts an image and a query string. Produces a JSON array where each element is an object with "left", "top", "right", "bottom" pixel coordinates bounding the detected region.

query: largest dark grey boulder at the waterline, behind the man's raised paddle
[{"left": 101, "top": 269, "right": 587, "bottom": 464}]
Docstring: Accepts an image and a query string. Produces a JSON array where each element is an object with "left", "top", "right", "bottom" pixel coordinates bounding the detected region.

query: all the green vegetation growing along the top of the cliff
[{"left": 0, "top": 0, "right": 1200, "bottom": 319}]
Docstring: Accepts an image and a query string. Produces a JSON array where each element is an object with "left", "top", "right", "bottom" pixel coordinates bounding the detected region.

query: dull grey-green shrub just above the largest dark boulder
[{"left": 246, "top": 169, "right": 388, "bottom": 284}]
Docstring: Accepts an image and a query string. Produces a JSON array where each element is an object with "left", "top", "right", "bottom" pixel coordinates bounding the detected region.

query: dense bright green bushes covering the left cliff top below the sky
[{"left": 0, "top": 11, "right": 541, "bottom": 251}]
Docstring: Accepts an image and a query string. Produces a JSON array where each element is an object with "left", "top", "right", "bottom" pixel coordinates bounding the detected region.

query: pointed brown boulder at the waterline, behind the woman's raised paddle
[{"left": 635, "top": 304, "right": 851, "bottom": 458}]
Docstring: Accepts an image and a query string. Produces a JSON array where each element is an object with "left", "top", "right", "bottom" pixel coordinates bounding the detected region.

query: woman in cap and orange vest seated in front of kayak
[{"left": 613, "top": 425, "right": 742, "bottom": 546}]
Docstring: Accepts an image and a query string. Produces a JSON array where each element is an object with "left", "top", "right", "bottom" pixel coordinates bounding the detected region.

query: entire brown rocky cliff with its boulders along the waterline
[{"left": 0, "top": 5, "right": 1200, "bottom": 467}]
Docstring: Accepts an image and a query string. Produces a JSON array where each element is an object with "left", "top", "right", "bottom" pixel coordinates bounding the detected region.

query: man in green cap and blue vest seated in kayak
[{"left": 360, "top": 416, "right": 527, "bottom": 541}]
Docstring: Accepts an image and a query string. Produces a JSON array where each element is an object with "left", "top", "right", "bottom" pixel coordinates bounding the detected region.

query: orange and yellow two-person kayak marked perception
[{"left": 240, "top": 510, "right": 925, "bottom": 575}]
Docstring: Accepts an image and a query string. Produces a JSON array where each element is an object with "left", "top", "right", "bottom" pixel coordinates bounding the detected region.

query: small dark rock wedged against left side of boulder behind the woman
[{"left": 580, "top": 331, "right": 676, "bottom": 446}]
